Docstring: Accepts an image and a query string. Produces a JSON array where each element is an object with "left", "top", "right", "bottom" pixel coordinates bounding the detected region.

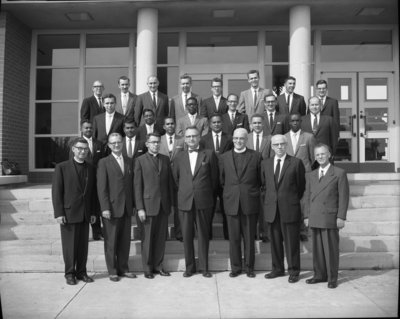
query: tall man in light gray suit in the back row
[{"left": 238, "top": 70, "right": 272, "bottom": 118}]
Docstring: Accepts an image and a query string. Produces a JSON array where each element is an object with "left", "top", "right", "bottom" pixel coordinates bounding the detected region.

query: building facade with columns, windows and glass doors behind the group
[{"left": 0, "top": 0, "right": 400, "bottom": 182}]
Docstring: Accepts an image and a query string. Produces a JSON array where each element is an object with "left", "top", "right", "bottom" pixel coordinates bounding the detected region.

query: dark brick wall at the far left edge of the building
[{"left": 0, "top": 12, "right": 31, "bottom": 174}]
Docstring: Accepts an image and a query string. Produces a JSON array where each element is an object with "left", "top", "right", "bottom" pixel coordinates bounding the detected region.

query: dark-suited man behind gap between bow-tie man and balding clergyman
[{"left": 200, "top": 113, "right": 233, "bottom": 240}]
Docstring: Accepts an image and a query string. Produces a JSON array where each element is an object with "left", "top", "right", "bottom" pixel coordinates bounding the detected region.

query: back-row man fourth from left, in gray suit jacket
[{"left": 169, "top": 73, "right": 202, "bottom": 122}]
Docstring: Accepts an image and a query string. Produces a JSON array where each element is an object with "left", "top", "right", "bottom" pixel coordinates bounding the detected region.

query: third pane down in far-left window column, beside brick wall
[{"left": 35, "top": 103, "right": 78, "bottom": 134}]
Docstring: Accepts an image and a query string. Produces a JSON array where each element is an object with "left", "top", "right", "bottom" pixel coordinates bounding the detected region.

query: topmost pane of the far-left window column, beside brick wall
[{"left": 37, "top": 34, "right": 79, "bottom": 66}]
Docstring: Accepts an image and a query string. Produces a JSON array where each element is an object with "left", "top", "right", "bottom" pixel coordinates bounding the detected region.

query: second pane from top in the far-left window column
[{"left": 36, "top": 69, "right": 79, "bottom": 100}]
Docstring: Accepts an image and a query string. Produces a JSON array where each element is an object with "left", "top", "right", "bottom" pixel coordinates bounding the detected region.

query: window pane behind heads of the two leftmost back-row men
[{"left": 85, "top": 68, "right": 127, "bottom": 96}]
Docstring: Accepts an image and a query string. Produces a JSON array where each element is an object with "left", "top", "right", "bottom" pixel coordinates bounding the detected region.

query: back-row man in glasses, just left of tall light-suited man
[{"left": 200, "top": 78, "right": 228, "bottom": 119}]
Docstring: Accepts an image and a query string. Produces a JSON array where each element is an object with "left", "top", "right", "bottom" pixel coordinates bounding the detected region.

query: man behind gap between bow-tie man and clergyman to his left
[{"left": 160, "top": 117, "right": 185, "bottom": 241}]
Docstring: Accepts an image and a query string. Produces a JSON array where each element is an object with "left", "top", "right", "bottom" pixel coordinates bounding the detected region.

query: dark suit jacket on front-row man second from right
[{"left": 261, "top": 155, "right": 306, "bottom": 223}]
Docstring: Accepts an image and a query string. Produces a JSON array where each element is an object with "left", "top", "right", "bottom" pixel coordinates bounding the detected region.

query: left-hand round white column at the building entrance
[{"left": 136, "top": 8, "right": 158, "bottom": 94}]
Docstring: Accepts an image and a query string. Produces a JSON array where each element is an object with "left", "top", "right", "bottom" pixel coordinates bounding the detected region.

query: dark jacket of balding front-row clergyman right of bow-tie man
[{"left": 219, "top": 149, "right": 261, "bottom": 215}]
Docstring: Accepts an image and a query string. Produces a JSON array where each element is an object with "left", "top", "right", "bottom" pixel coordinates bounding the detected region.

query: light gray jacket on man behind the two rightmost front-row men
[{"left": 286, "top": 130, "right": 316, "bottom": 172}]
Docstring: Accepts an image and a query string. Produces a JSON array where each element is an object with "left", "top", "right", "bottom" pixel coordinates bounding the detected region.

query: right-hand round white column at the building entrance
[{"left": 289, "top": 6, "right": 311, "bottom": 102}]
